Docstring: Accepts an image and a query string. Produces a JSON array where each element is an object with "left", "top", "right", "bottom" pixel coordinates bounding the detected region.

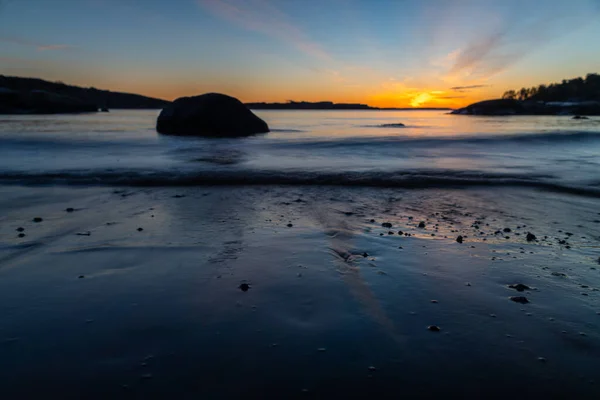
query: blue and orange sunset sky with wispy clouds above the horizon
[{"left": 0, "top": 0, "right": 600, "bottom": 107}]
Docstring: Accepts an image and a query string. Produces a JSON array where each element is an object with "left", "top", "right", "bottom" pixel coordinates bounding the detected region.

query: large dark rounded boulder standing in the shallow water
[{"left": 156, "top": 93, "right": 269, "bottom": 137}]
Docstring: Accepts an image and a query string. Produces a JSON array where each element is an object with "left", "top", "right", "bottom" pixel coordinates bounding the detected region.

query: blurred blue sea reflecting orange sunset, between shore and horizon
[{"left": 0, "top": 110, "right": 600, "bottom": 195}]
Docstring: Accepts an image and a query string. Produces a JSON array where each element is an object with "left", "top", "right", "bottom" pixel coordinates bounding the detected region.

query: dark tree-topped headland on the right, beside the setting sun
[{"left": 452, "top": 74, "right": 600, "bottom": 115}]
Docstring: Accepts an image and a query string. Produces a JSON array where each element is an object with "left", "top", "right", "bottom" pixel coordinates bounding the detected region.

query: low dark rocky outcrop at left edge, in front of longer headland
[{"left": 0, "top": 88, "right": 98, "bottom": 114}]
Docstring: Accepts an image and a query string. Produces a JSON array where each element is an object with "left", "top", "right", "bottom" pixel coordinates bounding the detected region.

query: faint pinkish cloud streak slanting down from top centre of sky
[{"left": 196, "top": 0, "right": 332, "bottom": 61}]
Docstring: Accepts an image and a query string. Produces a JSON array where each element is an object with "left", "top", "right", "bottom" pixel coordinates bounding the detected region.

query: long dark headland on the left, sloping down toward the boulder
[{"left": 0, "top": 75, "right": 169, "bottom": 114}]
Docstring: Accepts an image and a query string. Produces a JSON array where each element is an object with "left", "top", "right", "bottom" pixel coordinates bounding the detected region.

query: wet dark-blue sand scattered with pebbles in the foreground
[{"left": 0, "top": 186, "right": 600, "bottom": 399}]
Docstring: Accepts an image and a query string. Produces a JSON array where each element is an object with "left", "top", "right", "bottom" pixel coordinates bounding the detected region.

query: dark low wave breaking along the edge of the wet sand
[{"left": 0, "top": 170, "right": 600, "bottom": 197}]
